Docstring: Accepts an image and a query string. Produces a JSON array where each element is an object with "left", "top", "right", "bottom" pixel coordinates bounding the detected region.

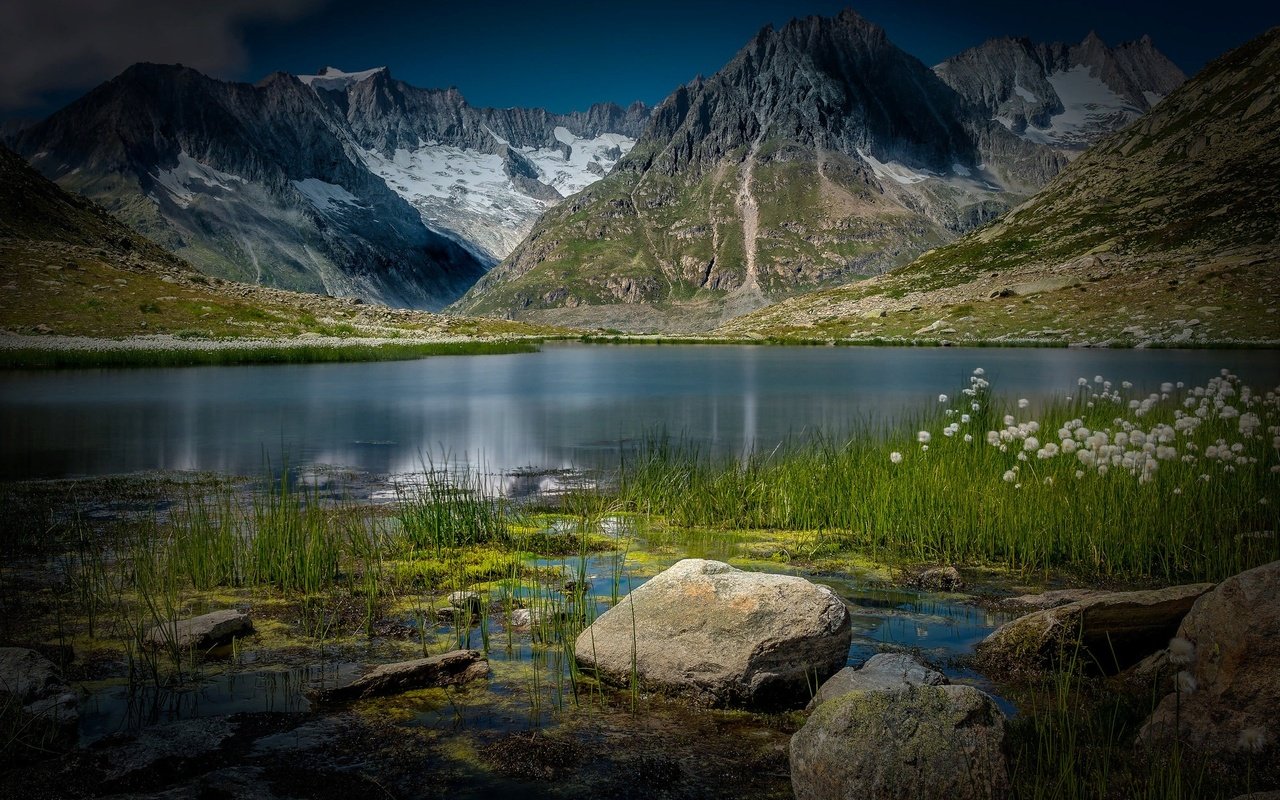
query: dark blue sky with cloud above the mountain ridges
[{"left": 0, "top": 0, "right": 1280, "bottom": 118}]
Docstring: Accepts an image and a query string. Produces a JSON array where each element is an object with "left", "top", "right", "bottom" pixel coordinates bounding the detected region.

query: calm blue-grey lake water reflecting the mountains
[{"left": 0, "top": 344, "right": 1280, "bottom": 479}]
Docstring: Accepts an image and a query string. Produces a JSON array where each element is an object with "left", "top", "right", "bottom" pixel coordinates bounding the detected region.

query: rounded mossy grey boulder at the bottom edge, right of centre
[{"left": 791, "top": 686, "right": 1009, "bottom": 800}]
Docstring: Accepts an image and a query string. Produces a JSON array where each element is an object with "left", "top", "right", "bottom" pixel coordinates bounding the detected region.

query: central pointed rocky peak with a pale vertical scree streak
[{"left": 456, "top": 12, "right": 1066, "bottom": 330}]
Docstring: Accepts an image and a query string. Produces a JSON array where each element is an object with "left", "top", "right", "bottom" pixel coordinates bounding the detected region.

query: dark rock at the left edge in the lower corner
[{"left": 0, "top": 648, "right": 79, "bottom": 753}]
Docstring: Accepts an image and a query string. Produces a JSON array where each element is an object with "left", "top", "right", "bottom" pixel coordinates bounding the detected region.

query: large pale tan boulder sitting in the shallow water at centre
[{"left": 573, "top": 558, "right": 852, "bottom": 707}]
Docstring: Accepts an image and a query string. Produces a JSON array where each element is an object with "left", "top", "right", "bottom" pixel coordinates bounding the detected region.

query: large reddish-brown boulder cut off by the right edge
[{"left": 1138, "top": 561, "right": 1280, "bottom": 755}]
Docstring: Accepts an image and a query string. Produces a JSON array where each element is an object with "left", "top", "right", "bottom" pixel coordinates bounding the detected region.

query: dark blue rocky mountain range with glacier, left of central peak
[{"left": 13, "top": 64, "right": 646, "bottom": 308}]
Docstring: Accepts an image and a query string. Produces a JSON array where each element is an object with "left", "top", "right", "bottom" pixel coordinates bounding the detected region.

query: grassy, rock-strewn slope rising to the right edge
[{"left": 719, "top": 28, "right": 1280, "bottom": 346}]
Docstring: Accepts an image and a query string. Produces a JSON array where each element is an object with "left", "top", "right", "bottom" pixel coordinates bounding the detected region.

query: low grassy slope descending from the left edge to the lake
[{"left": 0, "top": 146, "right": 538, "bottom": 343}]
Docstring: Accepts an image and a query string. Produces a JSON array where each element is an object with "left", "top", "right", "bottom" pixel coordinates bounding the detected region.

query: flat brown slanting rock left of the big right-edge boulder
[{"left": 978, "top": 584, "right": 1213, "bottom": 673}]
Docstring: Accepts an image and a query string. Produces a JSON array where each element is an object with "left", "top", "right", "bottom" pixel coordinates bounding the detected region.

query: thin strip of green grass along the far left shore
[{"left": 0, "top": 340, "right": 539, "bottom": 370}]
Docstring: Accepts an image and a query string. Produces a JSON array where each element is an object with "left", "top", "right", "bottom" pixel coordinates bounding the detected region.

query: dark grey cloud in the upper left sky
[{"left": 0, "top": 0, "right": 325, "bottom": 110}]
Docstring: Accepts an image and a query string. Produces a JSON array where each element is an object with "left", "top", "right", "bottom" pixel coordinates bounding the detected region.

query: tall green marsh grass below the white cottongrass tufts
[{"left": 617, "top": 373, "right": 1280, "bottom": 581}]
